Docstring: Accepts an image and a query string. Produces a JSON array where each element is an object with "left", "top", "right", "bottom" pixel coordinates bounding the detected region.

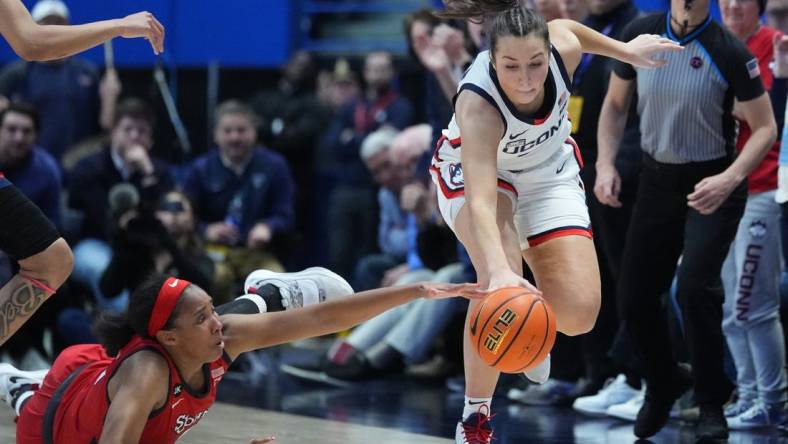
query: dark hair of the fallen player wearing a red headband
[{"left": 93, "top": 274, "right": 180, "bottom": 356}]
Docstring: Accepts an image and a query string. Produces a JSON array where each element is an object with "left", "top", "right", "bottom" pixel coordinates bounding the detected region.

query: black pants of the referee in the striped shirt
[{"left": 618, "top": 155, "right": 747, "bottom": 405}]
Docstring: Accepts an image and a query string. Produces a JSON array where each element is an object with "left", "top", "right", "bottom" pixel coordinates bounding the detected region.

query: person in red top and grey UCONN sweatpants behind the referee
[{"left": 720, "top": 0, "right": 788, "bottom": 430}]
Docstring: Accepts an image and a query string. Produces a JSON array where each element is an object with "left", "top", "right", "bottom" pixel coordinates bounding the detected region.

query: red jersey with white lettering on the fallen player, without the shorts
[{"left": 54, "top": 337, "right": 230, "bottom": 444}]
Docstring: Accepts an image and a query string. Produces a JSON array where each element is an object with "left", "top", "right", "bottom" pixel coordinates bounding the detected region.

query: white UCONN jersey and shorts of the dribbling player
[{"left": 430, "top": 48, "right": 591, "bottom": 250}]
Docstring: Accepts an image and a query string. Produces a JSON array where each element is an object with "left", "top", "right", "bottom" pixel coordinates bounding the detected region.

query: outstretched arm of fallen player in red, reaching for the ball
[{"left": 222, "top": 283, "right": 486, "bottom": 359}]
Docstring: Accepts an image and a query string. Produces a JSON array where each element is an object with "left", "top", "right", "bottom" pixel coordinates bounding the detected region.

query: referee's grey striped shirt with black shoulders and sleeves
[{"left": 615, "top": 12, "right": 764, "bottom": 164}]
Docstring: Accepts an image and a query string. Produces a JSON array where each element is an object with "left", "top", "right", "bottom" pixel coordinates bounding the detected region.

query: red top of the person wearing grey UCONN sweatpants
[{"left": 736, "top": 26, "right": 782, "bottom": 193}]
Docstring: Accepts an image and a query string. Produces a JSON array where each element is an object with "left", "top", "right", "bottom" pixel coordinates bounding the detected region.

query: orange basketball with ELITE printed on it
[{"left": 470, "top": 288, "right": 555, "bottom": 373}]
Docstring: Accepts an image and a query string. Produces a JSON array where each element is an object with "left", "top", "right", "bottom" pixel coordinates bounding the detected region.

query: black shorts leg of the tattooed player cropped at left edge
[{"left": 0, "top": 172, "right": 60, "bottom": 260}]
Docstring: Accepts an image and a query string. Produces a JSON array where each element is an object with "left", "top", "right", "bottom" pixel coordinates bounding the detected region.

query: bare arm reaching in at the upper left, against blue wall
[{"left": 0, "top": 0, "right": 164, "bottom": 60}]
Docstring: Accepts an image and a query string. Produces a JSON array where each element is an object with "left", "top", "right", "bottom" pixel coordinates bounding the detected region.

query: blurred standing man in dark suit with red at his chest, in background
[{"left": 320, "top": 52, "right": 412, "bottom": 276}]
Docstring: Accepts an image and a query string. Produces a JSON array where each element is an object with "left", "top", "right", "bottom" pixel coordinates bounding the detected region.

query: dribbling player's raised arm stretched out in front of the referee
[{"left": 548, "top": 19, "right": 683, "bottom": 72}]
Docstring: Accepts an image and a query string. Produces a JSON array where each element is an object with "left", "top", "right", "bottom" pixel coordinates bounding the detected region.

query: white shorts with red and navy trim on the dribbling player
[{"left": 430, "top": 139, "right": 592, "bottom": 250}]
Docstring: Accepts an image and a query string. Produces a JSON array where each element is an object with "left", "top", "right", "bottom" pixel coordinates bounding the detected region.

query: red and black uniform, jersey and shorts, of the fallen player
[{"left": 16, "top": 337, "right": 231, "bottom": 444}]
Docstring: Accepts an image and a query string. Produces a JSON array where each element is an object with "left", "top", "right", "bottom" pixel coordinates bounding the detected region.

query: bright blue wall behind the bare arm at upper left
[{"left": 0, "top": 0, "right": 294, "bottom": 67}]
